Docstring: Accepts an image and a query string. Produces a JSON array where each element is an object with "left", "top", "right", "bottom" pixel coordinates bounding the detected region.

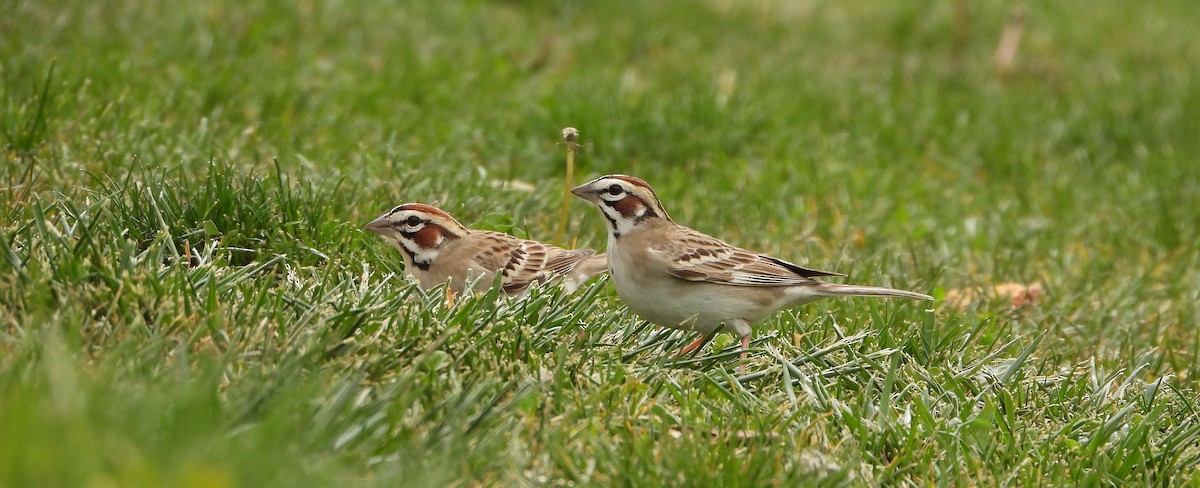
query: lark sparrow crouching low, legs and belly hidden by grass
[{"left": 366, "top": 204, "right": 607, "bottom": 295}]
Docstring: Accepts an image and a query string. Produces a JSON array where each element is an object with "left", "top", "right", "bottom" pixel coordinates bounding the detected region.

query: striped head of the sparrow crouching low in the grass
[{"left": 364, "top": 204, "right": 470, "bottom": 270}]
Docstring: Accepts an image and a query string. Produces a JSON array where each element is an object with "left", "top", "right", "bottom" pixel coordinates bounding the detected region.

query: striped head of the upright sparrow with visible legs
[{"left": 571, "top": 175, "right": 671, "bottom": 237}]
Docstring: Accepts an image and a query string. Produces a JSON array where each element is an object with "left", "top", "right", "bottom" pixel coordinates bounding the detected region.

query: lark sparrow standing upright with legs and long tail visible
[{"left": 571, "top": 175, "right": 934, "bottom": 359}]
